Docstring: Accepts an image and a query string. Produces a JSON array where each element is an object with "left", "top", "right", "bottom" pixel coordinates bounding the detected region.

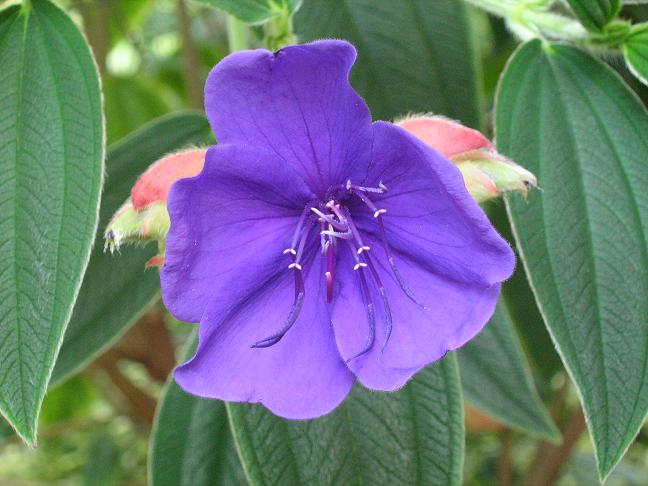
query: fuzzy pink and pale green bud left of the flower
[{"left": 104, "top": 149, "right": 206, "bottom": 267}]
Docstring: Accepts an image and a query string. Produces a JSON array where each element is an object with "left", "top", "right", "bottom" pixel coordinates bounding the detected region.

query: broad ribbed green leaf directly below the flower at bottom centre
[{"left": 227, "top": 355, "right": 464, "bottom": 486}]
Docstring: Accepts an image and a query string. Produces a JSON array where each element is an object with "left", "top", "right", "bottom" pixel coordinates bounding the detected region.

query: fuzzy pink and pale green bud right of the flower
[{"left": 396, "top": 116, "right": 536, "bottom": 203}]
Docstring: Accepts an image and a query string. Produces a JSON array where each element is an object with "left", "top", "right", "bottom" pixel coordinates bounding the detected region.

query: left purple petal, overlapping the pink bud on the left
[{"left": 160, "top": 145, "right": 313, "bottom": 322}]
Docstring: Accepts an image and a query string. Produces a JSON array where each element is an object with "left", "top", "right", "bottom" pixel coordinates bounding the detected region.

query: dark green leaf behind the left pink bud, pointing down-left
[{"left": 52, "top": 112, "right": 210, "bottom": 383}]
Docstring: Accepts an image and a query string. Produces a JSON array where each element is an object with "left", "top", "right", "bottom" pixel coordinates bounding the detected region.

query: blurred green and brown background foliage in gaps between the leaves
[{"left": 0, "top": 0, "right": 648, "bottom": 486}]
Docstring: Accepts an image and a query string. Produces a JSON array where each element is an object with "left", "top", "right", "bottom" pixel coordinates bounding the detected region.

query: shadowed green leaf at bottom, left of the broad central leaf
[{"left": 149, "top": 337, "right": 246, "bottom": 486}]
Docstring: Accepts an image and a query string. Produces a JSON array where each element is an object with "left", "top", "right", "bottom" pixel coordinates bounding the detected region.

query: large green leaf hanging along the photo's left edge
[{"left": 0, "top": 0, "right": 104, "bottom": 444}]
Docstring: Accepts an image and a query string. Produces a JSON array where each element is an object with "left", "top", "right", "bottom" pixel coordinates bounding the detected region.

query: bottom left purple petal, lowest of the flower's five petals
[{"left": 175, "top": 254, "right": 355, "bottom": 419}]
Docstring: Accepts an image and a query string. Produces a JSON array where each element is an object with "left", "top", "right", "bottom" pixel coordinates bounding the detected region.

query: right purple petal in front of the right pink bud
[{"left": 353, "top": 122, "right": 515, "bottom": 287}]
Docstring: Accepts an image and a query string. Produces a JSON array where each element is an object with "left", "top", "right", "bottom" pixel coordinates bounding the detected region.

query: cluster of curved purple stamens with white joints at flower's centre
[{"left": 252, "top": 180, "right": 425, "bottom": 361}]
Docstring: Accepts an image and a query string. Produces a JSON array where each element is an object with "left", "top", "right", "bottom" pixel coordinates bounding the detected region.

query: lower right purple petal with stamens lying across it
[{"left": 332, "top": 243, "right": 500, "bottom": 391}]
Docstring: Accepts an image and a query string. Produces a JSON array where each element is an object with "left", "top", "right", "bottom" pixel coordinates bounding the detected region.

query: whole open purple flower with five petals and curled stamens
[{"left": 161, "top": 40, "right": 514, "bottom": 419}]
